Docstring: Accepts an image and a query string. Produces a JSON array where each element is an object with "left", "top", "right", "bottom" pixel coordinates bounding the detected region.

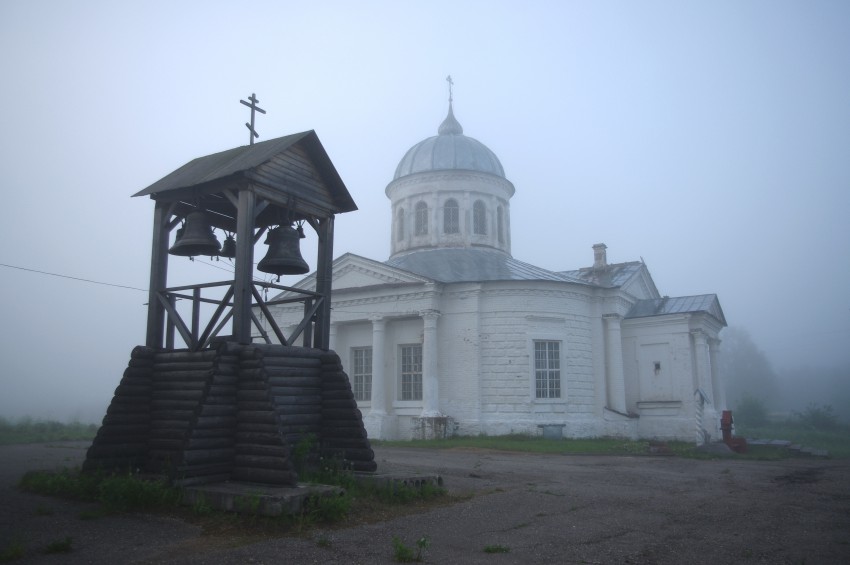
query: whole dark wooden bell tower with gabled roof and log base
[{"left": 83, "top": 129, "right": 376, "bottom": 486}]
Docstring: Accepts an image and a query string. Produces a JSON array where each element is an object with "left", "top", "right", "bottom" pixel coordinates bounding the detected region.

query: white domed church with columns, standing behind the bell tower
[{"left": 262, "top": 100, "right": 726, "bottom": 443}]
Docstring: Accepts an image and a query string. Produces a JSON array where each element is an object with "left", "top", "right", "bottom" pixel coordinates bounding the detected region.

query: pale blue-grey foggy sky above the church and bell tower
[{"left": 0, "top": 0, "right": 850, "bottom": 419}]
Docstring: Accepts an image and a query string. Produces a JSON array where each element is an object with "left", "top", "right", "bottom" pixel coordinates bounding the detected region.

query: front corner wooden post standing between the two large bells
[{"left": 233, "top": 188, "right": 256, "bottom": 344}]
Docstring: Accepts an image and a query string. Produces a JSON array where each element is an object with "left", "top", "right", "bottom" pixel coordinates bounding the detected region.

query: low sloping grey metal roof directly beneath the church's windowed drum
[{"left": 385, "top": 248, "right": 588, "bottom": 284}]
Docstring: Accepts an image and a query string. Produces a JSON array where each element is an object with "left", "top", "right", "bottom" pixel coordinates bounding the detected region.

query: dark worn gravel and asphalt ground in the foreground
[{"left": 0, "top": 442, "right": 850, "bottom": 565}]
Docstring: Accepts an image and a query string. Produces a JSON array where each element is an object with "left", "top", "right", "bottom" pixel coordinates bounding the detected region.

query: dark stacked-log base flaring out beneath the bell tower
[{"left": 84, "top": 343, "right": 377, "bottom": 486}]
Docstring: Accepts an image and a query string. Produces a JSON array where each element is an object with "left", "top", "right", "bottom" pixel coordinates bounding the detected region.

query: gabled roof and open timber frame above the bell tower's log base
[{"left": 134, "top": 131, "right": 357, "bottom": 351}]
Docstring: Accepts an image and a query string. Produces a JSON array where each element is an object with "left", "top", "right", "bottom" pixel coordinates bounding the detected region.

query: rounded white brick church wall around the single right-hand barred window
[{"left": 470, "top": 283, "right": 602, "bottom": 437}]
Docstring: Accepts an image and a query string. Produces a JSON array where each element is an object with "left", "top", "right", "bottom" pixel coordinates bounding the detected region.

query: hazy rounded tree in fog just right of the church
[{"left": 717, "top": 327, "right": 780, "bottom": 410}]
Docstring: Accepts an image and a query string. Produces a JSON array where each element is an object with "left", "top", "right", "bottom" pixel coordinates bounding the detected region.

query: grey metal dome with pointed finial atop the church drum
[{"left": 393, "top": 102, "right": 505, "bottom": 180}]
